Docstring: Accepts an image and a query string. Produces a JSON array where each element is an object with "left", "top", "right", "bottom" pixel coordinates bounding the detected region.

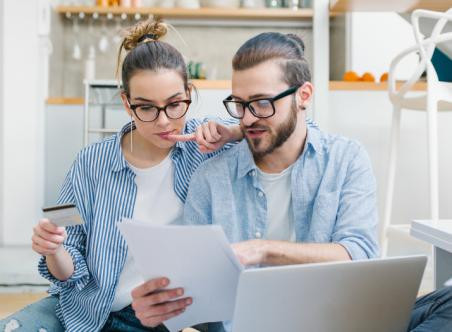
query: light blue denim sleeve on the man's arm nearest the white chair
[{"left": 332, "top": 145, "right": 379, "bottom": 260}]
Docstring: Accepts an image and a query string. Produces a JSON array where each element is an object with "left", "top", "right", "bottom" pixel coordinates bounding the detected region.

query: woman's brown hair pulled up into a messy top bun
[{"left": 116, "top": 18, "right": 189, "bottom": 95}]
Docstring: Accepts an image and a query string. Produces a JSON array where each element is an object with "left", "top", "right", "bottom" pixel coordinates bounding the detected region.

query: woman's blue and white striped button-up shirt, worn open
[{"left": 38, "top": 119, "right": 231, "bottom": 332}]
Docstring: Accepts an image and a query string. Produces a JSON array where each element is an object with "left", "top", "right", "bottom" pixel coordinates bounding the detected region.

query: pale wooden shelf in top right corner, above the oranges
[{"left": 330, "top": 0, "right": 452, "bottom": 13}]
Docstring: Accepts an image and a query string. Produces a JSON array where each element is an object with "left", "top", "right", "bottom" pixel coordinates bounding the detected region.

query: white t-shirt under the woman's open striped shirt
[{"left": 111, "top": 154, "right": 183, "bottom": 311}]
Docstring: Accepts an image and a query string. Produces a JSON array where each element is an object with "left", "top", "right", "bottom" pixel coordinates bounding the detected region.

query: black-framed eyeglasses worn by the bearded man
[{"left": 223, "top": 85, "right": 300, "bottom": 119}]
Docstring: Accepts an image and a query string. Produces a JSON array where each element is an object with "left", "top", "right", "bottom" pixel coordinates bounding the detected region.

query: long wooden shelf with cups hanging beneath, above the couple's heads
[{"left": 55, "top": 6, "right": 314, "bottom": 21}]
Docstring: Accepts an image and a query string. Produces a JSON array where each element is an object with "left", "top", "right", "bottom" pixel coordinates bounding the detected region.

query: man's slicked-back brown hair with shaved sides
[{"left": 232, "top": 32, "right": 311, "bottom": 86}]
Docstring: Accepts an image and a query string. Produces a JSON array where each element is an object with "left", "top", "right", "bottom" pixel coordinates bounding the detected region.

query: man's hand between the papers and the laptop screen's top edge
[{"left": 232, "top": 240, "right": 269, "bottom": 266}]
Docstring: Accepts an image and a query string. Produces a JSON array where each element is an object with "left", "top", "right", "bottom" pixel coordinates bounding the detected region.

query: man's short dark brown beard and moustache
[{"left": 240, "top": 107, "right": 297, "bottom": 162}]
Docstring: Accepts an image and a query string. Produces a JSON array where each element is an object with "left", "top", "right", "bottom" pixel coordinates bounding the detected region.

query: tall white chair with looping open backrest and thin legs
[{"left": 380, "top": 9, "right": 452, "bottom": 257}]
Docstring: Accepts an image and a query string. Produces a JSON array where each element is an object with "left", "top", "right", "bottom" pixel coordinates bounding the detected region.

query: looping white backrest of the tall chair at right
[{"left": 388, "top": 8, "right": 452, "bottom": 103}]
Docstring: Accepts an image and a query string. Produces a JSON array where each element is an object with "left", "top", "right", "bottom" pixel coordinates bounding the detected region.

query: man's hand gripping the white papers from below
[{"left": 132, "top": 278, "right": 193, "bottom": 327}]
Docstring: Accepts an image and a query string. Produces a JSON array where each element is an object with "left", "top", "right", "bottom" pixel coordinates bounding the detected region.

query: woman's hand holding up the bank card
[{"left": 31, "top": 219, "right": 66, "bottom": 256}]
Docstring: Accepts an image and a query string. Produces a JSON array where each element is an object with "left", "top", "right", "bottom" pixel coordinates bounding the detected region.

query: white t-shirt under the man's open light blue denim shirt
[{"left": 257, "top": 165, "right": 295, "bottom": 242}]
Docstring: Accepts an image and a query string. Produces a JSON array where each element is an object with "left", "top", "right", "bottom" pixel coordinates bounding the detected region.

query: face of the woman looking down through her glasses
[{"left": 122, "top": 69, "right": 190, "bottom": 149}]
